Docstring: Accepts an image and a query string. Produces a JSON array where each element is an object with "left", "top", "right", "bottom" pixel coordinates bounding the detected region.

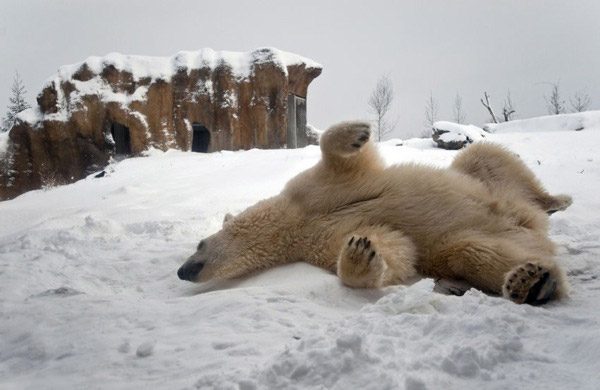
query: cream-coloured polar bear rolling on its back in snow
[{"left": 178, "top": 121, "right": 571, "bottom": 304}]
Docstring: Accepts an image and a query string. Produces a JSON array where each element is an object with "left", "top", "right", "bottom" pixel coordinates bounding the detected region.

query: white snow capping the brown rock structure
[{"left": 12, "top": 47, "right": 322, "bottom": 125}]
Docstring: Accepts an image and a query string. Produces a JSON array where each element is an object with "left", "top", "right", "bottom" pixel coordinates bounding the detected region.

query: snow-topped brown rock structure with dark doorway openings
[{"left": 0, "top": 48, "right": 321, "bottom": 200}]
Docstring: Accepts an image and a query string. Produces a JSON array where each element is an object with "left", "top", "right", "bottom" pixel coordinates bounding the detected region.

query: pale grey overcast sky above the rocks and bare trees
[{"left": 0, "top": 0, "right": 600, "bottom": 137}]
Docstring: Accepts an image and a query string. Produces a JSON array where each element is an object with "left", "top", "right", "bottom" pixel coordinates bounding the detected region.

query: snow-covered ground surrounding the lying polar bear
[{"left": 0, "top": 124, "right": 600, "bottom": 390}]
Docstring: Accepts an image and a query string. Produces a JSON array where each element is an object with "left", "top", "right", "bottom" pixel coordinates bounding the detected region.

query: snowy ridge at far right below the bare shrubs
[{"left": 484, "top": 111, "right": 600, "bottom": 133}]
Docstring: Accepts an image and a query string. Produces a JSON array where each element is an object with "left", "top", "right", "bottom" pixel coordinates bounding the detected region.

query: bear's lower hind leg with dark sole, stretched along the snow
[{"left": 423, "top": 233, "right": 567, "bottom": 305}]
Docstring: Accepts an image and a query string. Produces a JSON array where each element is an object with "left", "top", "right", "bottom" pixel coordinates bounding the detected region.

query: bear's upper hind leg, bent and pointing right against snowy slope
[{"left": 451, "top": 143, "right": 573, "bottom": 214}]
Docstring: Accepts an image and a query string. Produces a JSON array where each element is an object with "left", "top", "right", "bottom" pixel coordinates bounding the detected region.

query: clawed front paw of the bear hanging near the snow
[{"left": 338, "top": 236, "right": 386, "bottom": 287}]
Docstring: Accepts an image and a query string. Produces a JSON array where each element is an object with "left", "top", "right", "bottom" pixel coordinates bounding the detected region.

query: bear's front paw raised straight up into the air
[{"left": 319, "top": 121, "right": 384, "bottom": 172}]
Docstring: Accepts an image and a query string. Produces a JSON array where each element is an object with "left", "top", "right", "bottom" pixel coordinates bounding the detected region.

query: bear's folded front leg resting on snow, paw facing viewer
[{"left": 337, "top": 227, "right": 416, "bottom": 288}]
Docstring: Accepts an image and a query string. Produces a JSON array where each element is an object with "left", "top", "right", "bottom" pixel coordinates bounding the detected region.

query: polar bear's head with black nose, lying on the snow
[{"left": 177, "top": 198, "right": 289, "bottom": 282}]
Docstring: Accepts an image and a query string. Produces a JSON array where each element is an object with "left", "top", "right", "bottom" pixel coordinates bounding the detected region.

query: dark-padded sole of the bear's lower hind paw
[{"left": 502, "top": 263, "right": 557, "bottom": 305}]
